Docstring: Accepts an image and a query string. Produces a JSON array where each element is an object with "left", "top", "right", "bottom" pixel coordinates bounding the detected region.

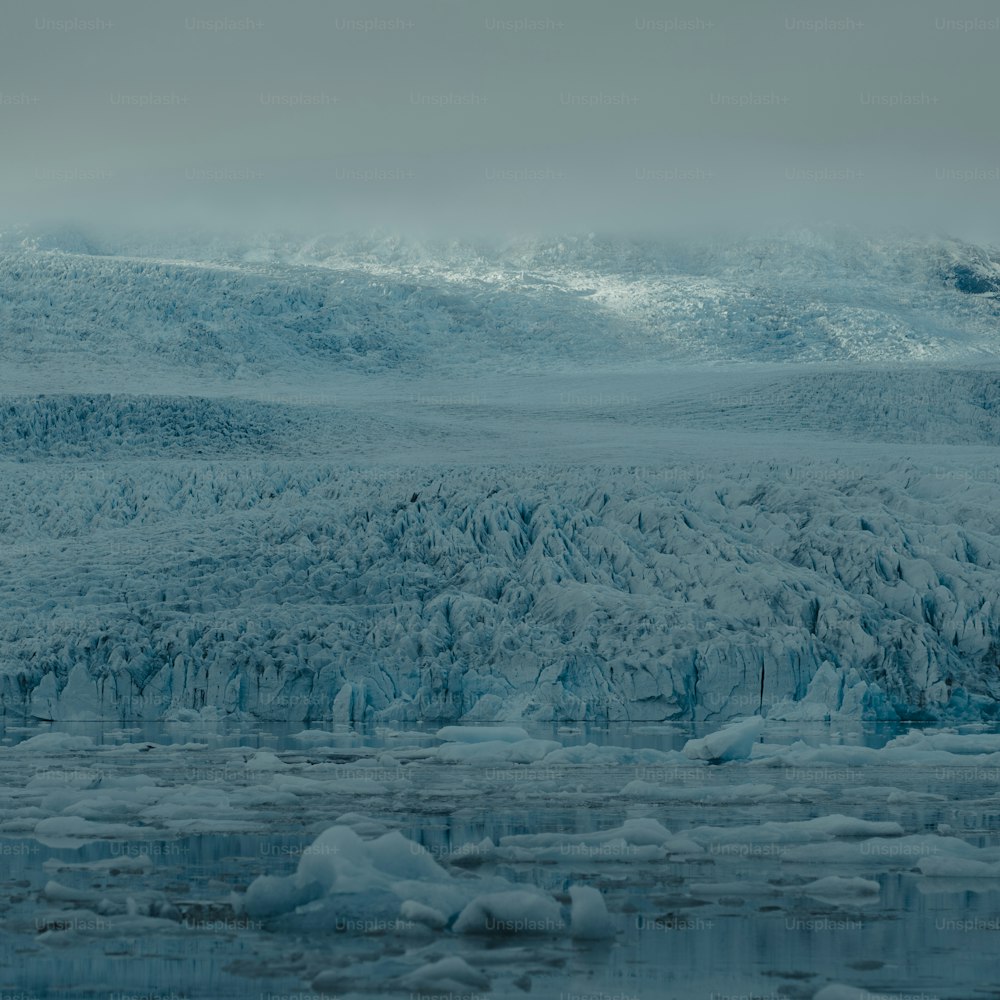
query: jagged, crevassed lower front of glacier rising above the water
[{"left": 0, "top": 462, "right": 1000, "bottom": 724}]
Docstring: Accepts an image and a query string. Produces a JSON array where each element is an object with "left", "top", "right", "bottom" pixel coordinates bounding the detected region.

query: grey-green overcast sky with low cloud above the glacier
[{"left": 0, "top": 0, "right": 1000, "bottom": 242}]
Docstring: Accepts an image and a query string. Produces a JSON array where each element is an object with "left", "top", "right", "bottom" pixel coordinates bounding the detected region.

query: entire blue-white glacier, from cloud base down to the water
[{"left": 0, "top": 229, "right": 1000, "bottom": 722}]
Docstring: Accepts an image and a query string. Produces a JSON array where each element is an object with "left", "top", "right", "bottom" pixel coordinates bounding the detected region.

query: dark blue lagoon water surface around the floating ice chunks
[{"left": 0, "top": 720, "right": 1000, "bottom": 1000}]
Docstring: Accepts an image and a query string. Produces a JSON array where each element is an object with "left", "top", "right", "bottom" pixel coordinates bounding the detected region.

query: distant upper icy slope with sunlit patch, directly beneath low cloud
[{"left": 0, "top": 232, "right": 1000, "bottom": 377}]
